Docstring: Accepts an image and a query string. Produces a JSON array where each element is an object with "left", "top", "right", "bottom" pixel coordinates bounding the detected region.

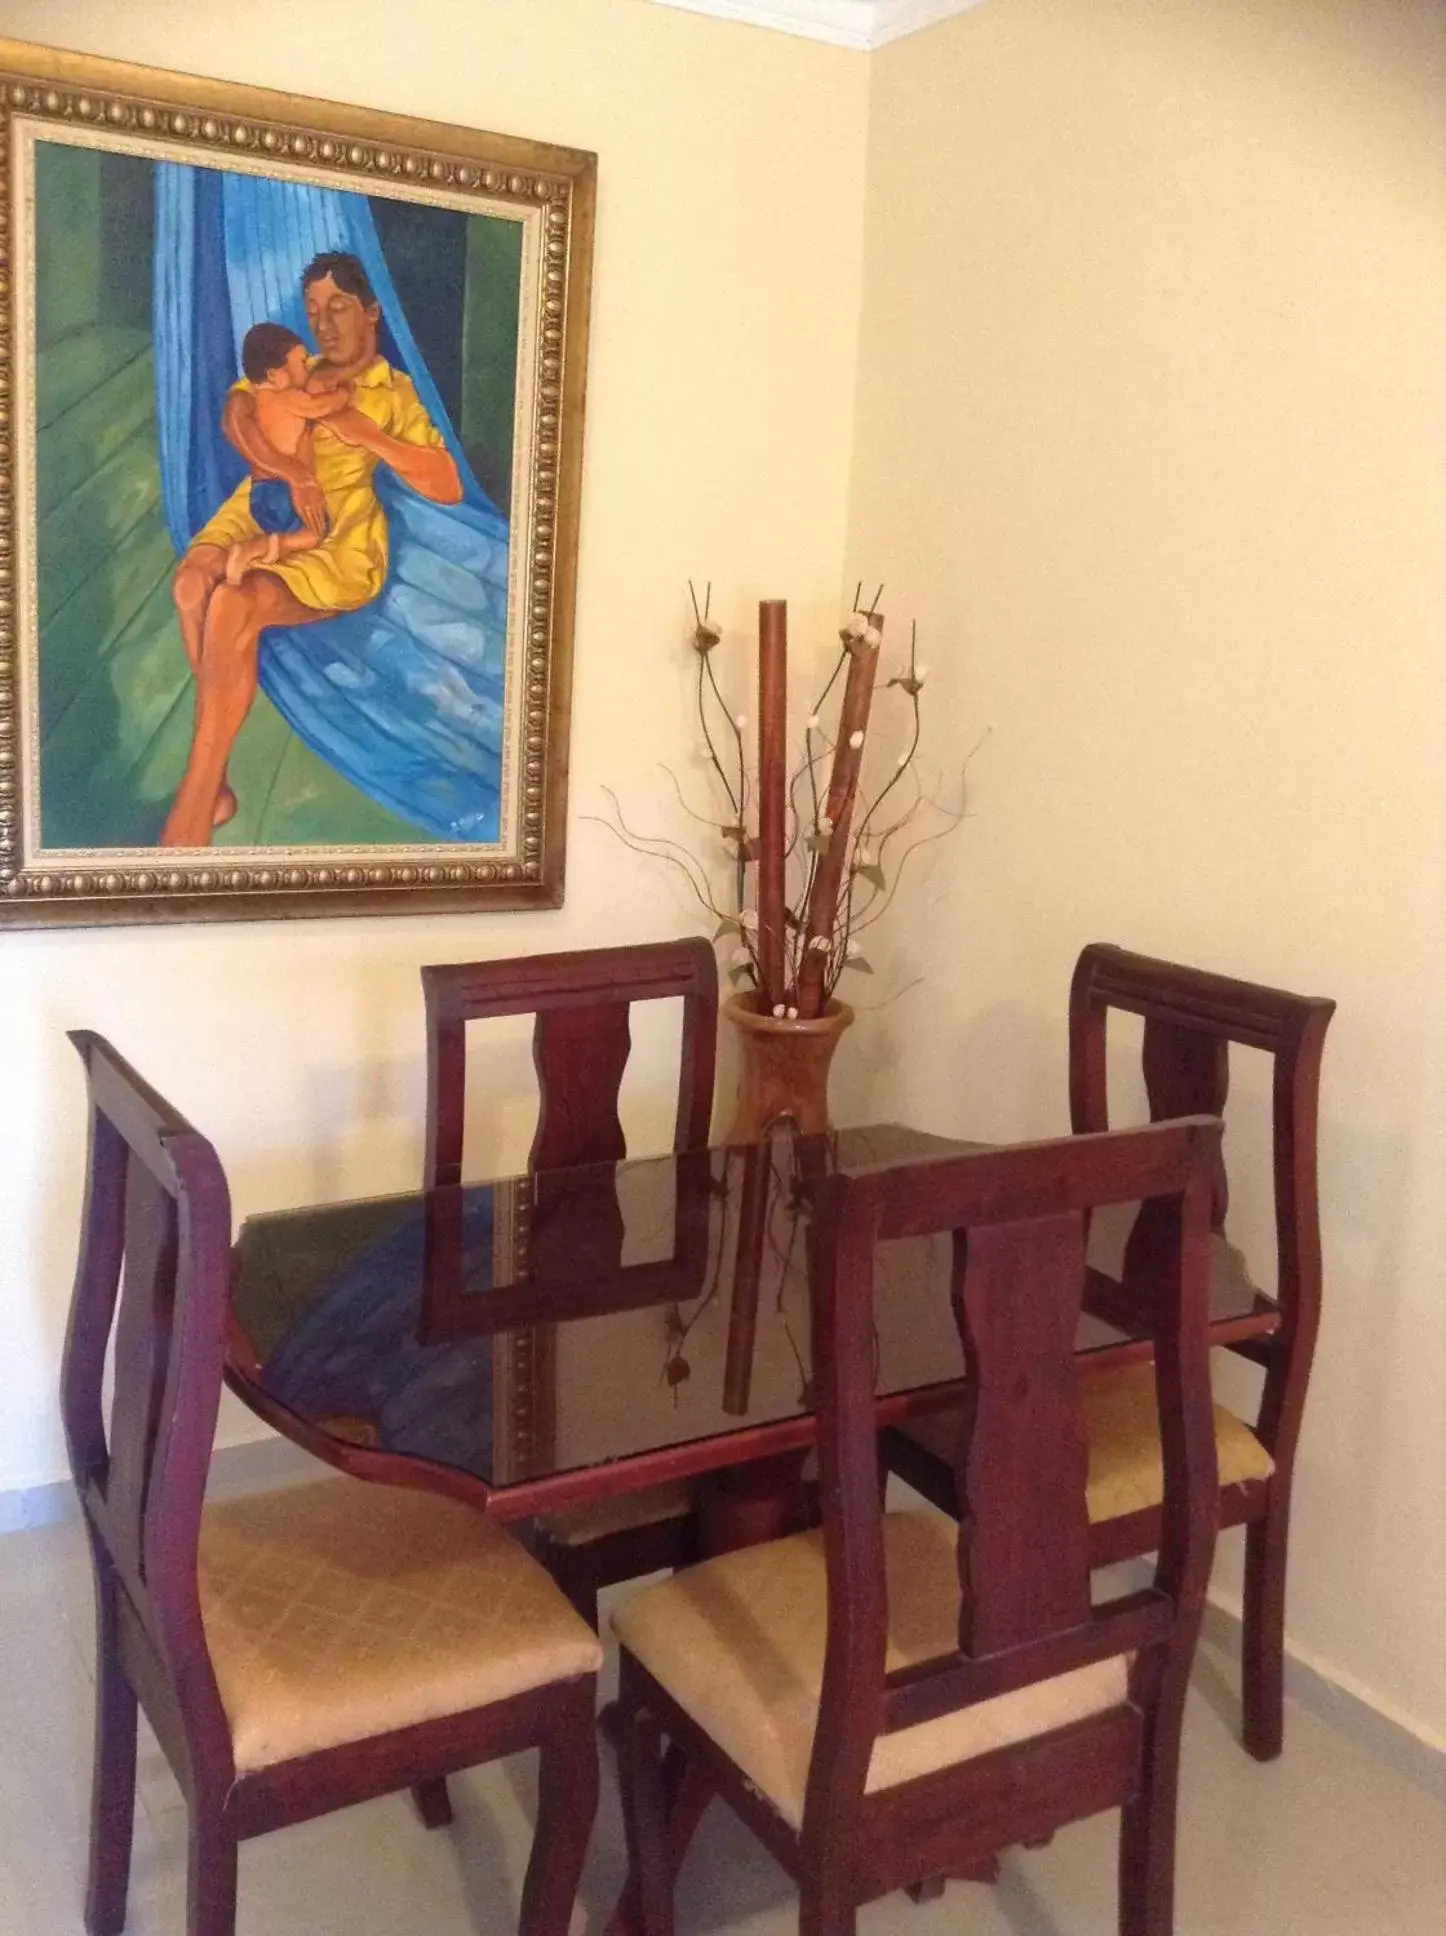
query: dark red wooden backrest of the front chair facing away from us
[{"left": 805, "top": 1117, "right": 1220, "bottom": 1837}]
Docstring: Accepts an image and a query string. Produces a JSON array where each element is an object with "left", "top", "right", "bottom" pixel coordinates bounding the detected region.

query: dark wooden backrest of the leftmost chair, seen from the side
[{"left": 60, "top": 1030, "right": 230, "bottom": 1754}]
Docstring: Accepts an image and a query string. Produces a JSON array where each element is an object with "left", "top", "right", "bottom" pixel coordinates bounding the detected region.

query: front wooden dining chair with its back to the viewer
[{"left": 614, "top": 1117, "right": 1220, "bottom": 1936}]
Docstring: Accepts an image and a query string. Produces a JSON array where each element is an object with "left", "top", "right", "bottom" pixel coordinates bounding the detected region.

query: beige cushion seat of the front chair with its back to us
[{"left": 614, "top": 1512, "right": 1129, "bottom": 1828}]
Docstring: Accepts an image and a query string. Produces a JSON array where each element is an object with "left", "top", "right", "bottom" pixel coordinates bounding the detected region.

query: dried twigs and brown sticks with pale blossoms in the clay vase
[{"left": 592, "top": 585, "right": 964, "bottom": 1020}]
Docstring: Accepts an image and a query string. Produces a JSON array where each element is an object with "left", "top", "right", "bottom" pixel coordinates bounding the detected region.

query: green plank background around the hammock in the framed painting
[{"left": 35, "top": 141, "right": 521, "bottom": 848}]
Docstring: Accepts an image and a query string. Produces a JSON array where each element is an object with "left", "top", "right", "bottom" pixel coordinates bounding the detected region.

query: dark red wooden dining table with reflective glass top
[{"left": 226, "top": 1123, "right": 1280, "bottom": 1936}]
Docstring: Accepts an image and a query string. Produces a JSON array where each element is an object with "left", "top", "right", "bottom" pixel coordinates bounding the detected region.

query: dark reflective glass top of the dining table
[{"left": 232, "top": 1125, "right": 1274, "bottom": 1489}]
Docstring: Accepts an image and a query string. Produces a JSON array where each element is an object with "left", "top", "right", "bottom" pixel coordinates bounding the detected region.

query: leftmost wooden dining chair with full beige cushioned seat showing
[{"left": 62, "top": 1032, "right": 602, "bottom": 1936}]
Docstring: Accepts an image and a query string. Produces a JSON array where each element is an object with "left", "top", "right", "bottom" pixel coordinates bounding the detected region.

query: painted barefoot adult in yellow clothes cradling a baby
[{"left": 161, "top": 252, "right": 463, "bottom": 846}]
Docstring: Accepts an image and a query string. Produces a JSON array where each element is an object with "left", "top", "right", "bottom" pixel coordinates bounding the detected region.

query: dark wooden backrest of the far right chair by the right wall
[{"left": 1069, "top": 941, "right": 1336, "bottom": 1338}]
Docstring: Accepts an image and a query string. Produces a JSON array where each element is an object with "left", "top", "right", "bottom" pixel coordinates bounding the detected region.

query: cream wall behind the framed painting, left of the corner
[{"left": 0, "top": 0, "right": 867, "bottom": 1491}]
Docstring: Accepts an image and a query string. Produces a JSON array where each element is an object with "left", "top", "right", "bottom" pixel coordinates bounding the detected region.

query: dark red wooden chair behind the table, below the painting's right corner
[{"left": 422, "top": 937, "right": 718, "bottom": 1628}]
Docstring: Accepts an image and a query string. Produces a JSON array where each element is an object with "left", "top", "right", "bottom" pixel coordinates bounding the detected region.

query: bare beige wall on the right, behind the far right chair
[{"left": 852, "top": 0, "right": 1446, "bottom": 1739}]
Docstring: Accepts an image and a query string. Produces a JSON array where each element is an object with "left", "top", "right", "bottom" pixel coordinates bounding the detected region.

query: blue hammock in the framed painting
[{"left": 153, "top": 163, "right": 507, "bottom": 840}]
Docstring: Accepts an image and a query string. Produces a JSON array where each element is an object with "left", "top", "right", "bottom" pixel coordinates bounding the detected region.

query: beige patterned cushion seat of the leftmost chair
[{"left": 199, "top": 1479, "right": 602, "bottom": 1773}]
